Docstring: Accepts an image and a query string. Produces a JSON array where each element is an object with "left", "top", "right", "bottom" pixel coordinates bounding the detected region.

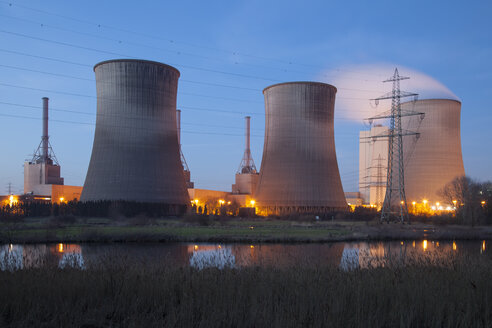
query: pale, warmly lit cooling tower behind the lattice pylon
[{"left": 401, "top": 99, "right": 465, "bottom": 204}]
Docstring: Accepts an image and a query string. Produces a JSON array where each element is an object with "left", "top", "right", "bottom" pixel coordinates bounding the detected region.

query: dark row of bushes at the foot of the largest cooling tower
[{"left": 0, "top": 201, "right": 187, "bottom": 218}]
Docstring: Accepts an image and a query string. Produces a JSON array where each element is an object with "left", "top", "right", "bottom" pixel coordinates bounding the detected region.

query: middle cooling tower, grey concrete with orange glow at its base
[{"left": 256, "top": 82, "right": 347, "bottom": 214}]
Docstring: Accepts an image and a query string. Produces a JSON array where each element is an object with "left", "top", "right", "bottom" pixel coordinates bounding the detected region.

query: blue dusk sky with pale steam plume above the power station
[{"left": 0, "top": 0, "right": 492, "bottom": 194}]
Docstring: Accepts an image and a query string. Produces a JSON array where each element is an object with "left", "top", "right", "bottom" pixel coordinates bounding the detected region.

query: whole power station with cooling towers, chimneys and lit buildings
[{"left": 3, "top": 59, "right": 465, "bottom": 219}]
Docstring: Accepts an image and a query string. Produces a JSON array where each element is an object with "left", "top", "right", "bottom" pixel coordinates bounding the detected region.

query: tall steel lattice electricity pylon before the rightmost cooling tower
[{"left": 369, "top": 68, "right": 423, "bottom": 223}]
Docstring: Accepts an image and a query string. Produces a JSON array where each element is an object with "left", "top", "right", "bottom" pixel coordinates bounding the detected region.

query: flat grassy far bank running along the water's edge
[{"left": 0, "top": 217, "right": 492, "bottom": 243}]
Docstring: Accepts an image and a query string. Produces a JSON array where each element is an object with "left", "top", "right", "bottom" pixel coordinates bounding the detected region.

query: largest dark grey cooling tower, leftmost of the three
[{"left": 80, "top": 59, "right": 189, "bottom": 205}]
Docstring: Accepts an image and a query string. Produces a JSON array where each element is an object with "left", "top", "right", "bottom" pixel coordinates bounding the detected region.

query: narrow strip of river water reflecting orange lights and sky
[{"left": 0, "top": 240, "right": 492, "bottom": 271}]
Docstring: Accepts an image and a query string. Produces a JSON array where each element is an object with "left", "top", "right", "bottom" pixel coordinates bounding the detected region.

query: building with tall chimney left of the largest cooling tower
[{"left": 24, "top": 97, "right": 82, "bottom": 202}]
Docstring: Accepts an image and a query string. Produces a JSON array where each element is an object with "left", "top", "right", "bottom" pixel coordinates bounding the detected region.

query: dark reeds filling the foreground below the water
[{"left": 0, "top": 259, "right": 492, "bottom": 327}]
